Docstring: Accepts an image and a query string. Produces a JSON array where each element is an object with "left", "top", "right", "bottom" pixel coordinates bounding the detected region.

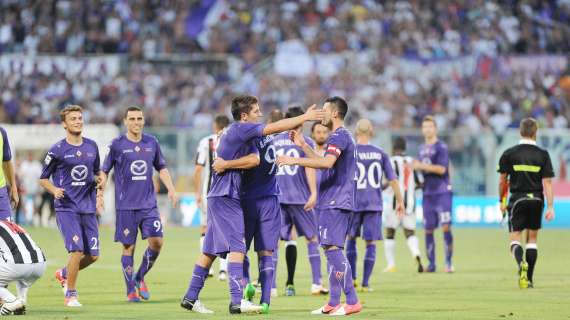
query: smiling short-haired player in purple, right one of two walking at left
[{"left": 101, "top": 106, "right": 178, "bottom": 302}]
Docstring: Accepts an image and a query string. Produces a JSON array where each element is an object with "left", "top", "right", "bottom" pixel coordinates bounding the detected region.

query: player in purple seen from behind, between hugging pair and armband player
[{"left": 274, "top": 107, "right": 328, "bottom": 295}]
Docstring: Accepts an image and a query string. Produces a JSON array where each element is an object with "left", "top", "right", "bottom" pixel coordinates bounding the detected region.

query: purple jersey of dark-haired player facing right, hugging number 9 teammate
[{"left": 208, "top": 122, "right": 265, "bottom": 199}]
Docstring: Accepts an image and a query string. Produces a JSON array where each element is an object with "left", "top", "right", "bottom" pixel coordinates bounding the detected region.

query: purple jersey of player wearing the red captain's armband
[{"left": 317, "top": 127, "right": 356, "bottom": 211}]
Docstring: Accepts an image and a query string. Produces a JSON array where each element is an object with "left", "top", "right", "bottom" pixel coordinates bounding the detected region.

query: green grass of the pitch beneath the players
[{"left": 18, "top": 228, "right": 570, "bottom": 320}]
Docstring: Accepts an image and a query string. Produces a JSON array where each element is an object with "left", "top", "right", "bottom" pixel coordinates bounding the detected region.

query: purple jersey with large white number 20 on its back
[{"left": 354, "top": 144, "right": 396, "bottom": 212}]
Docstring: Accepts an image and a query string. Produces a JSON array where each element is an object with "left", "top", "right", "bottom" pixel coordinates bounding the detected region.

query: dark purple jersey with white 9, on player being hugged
[{"left": 240, "top": 135, "right": 280, "bottom": 199}]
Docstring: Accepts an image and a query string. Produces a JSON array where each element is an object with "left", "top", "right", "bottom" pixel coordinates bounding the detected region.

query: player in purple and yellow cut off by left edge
[{"left": 0, "top": 127, "right": 20, "bottom": 221}]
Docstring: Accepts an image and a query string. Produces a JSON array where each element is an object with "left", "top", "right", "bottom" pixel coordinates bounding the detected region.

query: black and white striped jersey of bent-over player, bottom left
[{"left": 0, "top": 221, "right": 46, "bottom": 264}]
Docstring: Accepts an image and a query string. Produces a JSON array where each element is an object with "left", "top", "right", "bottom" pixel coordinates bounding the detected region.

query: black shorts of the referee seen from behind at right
[{"left": 507, "top": 193, "right": 544, "bottom": 232}]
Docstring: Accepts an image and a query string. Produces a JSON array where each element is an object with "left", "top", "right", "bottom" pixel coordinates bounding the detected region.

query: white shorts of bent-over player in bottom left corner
[{"left": 0, "top": 261, "right": 46, "bottom": 288}]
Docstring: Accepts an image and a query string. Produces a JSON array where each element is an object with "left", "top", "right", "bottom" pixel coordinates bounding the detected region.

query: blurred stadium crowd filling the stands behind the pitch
[{"left": 0, "top": 0, "right": 570, "bottom": 132}]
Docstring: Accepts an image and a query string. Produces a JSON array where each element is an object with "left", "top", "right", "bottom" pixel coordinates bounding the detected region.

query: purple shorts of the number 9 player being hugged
[{"left": 241, "top": 196, "right": 281, "bottom": 252}]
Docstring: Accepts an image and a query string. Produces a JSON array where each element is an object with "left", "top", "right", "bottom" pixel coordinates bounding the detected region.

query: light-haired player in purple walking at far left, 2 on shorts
[{"left": 40, "top": 105, "right": 103, "bottom": 307}]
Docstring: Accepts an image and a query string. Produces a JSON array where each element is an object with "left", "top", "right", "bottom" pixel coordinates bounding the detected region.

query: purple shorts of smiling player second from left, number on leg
[{"left": 115, "top": 207, "right": 163, "bottom": 245}]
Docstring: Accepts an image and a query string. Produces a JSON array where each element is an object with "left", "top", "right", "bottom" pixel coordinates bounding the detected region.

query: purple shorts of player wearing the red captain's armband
[{"left": 319, "top": 209, "right": 352, "bottom": 248}]
